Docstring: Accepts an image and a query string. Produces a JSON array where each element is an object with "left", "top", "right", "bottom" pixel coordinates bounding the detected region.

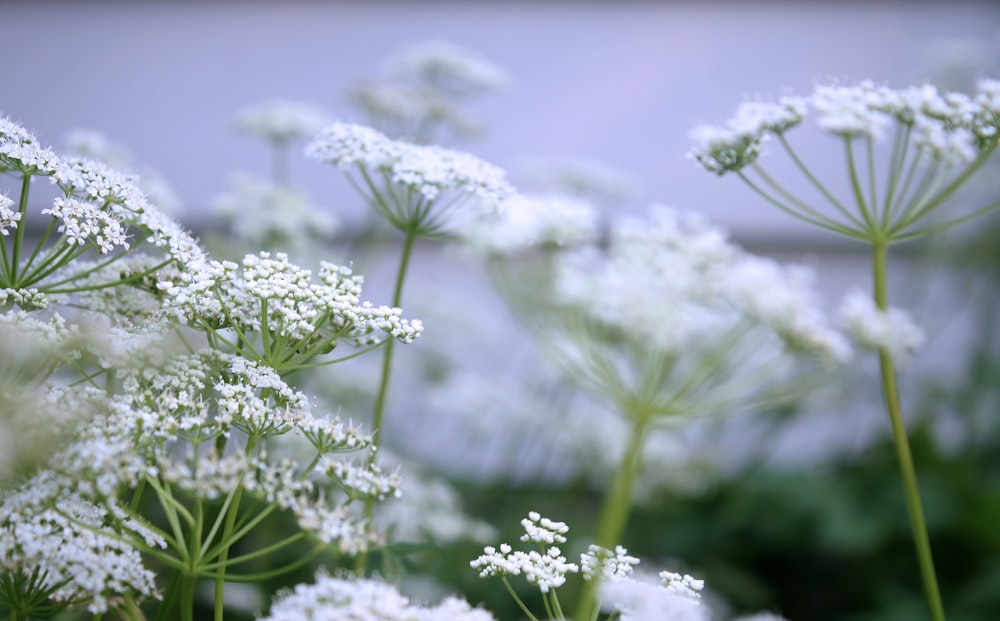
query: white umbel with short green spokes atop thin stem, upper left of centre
[{"left": 306, "top": 123, "right": 513, "bottom": 236}]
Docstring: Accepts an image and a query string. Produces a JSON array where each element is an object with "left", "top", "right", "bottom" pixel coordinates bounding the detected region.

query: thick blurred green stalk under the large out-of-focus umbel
[{"left": 572, "top": 413, "right": 651, "bottom": 621}]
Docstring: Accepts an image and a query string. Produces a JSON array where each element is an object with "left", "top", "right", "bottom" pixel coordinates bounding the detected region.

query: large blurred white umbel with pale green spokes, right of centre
[{"left": 539, "top": 206, "right": 850, "bottom": 417}]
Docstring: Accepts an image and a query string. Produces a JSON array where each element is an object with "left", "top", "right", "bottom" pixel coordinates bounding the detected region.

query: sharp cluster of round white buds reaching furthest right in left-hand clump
[{"left": 158, "top": 252, "right": 423, "bottom": 354}]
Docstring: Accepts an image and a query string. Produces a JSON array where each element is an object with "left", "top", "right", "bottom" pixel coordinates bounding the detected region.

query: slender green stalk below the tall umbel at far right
[{"left": 873, "top": 242, "right": 945, "bottom": 621}]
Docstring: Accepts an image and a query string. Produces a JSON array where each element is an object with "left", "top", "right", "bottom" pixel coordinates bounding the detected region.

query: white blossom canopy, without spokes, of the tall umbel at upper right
[{"left": 689, "top": 80, "right": 1000, "bottom": 175}]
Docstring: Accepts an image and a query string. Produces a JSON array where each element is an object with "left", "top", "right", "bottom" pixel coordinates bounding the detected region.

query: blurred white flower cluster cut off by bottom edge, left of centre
[{"left": 259, "top": 573, "right": 493, "bottom": 621}]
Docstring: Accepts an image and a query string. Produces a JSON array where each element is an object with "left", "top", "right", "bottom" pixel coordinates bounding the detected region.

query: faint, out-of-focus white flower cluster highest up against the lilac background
[{"left": 386, "top": 41, "right": 511, "bottom": 98}]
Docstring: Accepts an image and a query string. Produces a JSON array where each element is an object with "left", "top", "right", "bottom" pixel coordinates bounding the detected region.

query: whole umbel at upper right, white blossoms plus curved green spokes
[{"left": 689, "top": 80, "right": 1000, "bottom": 244}]
